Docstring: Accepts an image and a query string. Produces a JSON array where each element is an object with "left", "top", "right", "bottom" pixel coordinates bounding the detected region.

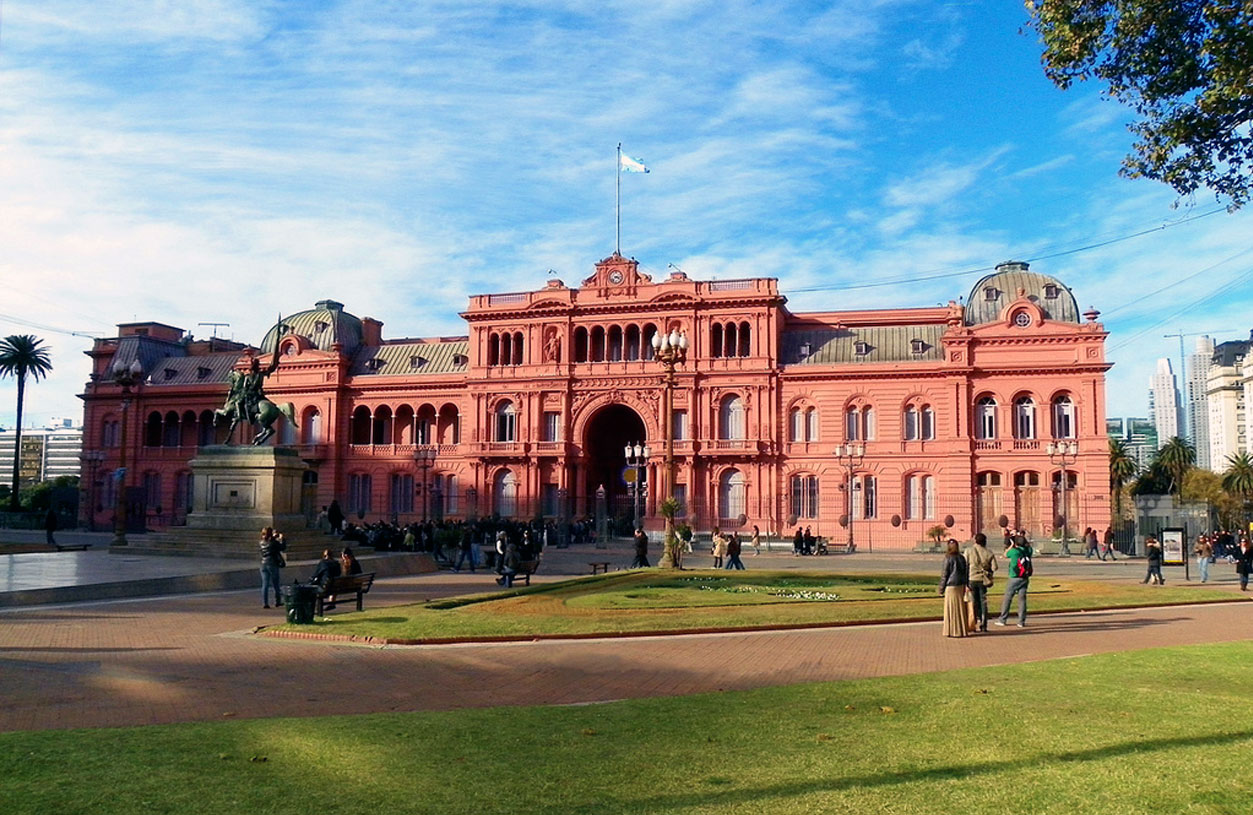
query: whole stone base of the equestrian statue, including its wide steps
[{"left": 110, "top": 445, "right": 342, "bottom": 560}]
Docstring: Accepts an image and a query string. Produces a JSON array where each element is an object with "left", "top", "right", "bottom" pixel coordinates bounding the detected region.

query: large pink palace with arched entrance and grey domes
[{"left": 83, "top": 255, "right": 1109, "bottom": 549}]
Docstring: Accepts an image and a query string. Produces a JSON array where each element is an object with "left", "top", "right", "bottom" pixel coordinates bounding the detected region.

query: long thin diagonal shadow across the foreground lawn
[{"left": 523, "top": 730, "right": 1253, "bottom": 815}]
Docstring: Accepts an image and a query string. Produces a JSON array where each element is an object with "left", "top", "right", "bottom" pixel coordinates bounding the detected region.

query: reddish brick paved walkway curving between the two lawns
[{"left": 0, "top": 567, "right": 1253, "bottom": 731}]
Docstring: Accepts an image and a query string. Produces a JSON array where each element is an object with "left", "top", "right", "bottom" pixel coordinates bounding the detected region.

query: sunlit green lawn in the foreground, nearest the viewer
[{"left": 0, "top": 642, "right": 1253, "bottom": 815}]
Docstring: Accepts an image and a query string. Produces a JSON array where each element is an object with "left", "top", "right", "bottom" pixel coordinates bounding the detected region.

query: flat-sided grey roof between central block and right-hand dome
[{"left": 779, "top": 325, "right": 947, "bottom": 365}]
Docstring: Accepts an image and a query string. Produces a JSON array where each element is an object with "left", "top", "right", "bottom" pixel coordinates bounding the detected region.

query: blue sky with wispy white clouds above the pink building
[{"left": 0, "top": 0, "right": 1253, "bottom": 425}]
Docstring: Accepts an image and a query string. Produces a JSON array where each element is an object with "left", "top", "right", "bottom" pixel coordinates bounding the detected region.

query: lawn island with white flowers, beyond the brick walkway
[{"left": 274, "top": 569, "right": 1234, "bottom": 642}]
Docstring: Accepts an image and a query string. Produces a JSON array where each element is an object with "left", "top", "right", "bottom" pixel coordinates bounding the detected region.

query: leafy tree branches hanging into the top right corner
[{"left": 1025, "top": 0, "right": 1253, "bottom": 209}]
